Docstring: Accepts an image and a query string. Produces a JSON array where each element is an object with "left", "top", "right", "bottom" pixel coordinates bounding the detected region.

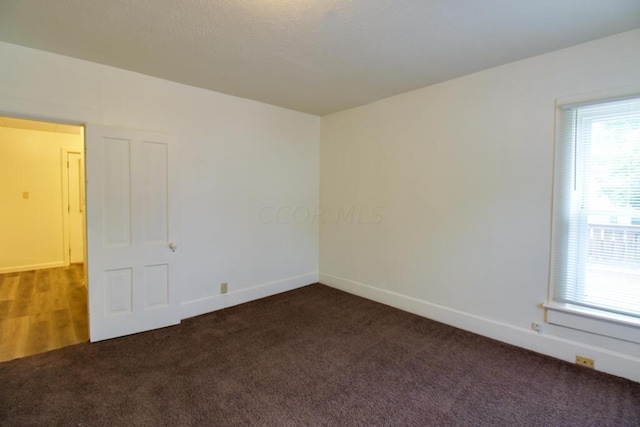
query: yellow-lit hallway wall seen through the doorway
[{"left": 0, "top": 127, "right": 84, "bottom": 273}]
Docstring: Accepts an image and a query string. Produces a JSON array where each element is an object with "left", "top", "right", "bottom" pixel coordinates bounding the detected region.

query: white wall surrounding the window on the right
[{"left": 320, "top": 30, "right": 640, "bottom": 381}]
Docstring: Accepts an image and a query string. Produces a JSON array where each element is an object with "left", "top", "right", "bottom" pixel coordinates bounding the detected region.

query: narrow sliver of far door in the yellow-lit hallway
[{"left": 67, "top": 151, "right": 85, "bottom": 263}]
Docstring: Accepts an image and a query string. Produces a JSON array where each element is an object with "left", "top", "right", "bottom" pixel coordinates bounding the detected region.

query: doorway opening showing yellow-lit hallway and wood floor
[{"left": 0, "top": 116, "right": 89, "bottom": 362}]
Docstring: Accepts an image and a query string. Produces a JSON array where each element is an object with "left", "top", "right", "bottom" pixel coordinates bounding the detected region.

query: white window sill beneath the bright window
[{"left": 542, "top": 302, "right": 640, "bottom": 344}]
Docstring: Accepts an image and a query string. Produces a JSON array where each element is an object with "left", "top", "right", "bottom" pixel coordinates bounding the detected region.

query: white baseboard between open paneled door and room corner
[{"left": 180, "top": 272, "right": 318, "bottom": 319}]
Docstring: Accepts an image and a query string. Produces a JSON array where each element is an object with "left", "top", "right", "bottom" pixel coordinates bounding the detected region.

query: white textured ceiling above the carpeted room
[{"left": 0, "top": 0, "right": 640, "bottom": 115}]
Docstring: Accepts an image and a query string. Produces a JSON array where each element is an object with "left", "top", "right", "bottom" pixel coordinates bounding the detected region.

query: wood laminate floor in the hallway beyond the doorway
[{"left": 0, "top": 264, "right": 89, "bottom": 362}]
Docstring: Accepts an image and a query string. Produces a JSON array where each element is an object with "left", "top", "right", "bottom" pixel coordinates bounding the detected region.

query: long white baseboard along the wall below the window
[{"left": 319, "top": 273, "right": 640, "bottom": 382}]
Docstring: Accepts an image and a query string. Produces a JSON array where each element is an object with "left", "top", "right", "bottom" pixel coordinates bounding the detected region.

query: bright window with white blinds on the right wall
[{"left": 551, "top": 97, "right": 640, "bottom": 319}]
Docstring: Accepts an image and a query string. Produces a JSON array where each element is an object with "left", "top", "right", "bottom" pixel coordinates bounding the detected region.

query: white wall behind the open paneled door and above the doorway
[{"left": 0, "top": 43, "right": 320, "bottom": 317}]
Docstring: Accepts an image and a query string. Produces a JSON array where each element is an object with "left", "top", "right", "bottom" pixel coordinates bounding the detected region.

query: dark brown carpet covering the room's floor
[{"left": 0, "top": 285, "right": 640, "bottom": 426}]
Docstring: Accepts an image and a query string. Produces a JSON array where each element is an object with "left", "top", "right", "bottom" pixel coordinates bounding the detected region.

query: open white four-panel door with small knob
[{"left": 85, "top": 125, "right": 180, "bottom": 341}]
